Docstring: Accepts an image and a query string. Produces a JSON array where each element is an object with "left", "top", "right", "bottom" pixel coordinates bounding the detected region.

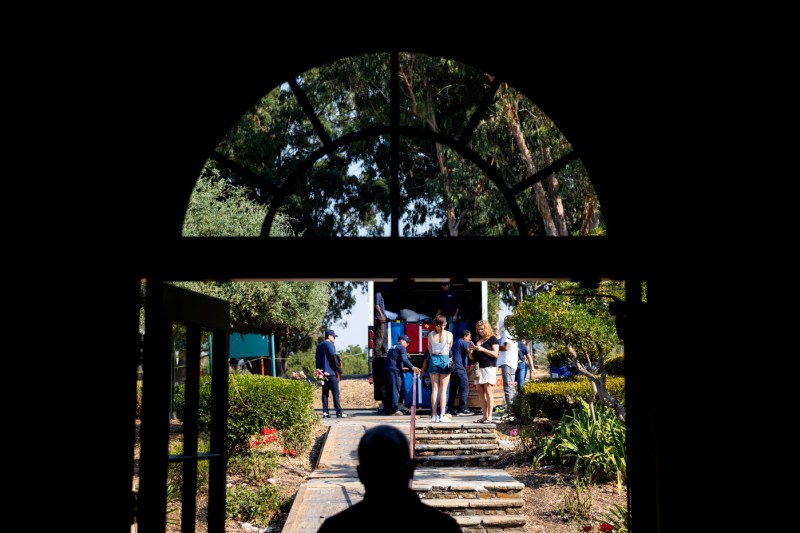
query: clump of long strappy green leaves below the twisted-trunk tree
[{"left": 536, "top": 400, "right": 627, "bottom": 490}]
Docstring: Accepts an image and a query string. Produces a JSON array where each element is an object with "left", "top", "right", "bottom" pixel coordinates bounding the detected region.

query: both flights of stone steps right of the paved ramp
[{"left": 413, "top": 421, "right": 526, "bottom": 533}]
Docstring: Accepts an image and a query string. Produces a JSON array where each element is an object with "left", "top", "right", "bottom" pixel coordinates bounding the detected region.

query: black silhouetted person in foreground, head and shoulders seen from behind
[{"left": 317, "top": 424, "right": 461, "bottom": 533}]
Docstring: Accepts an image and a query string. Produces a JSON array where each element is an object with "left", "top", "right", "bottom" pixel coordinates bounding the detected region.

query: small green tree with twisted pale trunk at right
[{"left": 505, "top": 282, "right": 625, "bottom": 423}]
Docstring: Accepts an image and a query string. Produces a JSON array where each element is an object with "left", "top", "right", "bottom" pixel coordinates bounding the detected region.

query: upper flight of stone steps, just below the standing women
[{"left": 414, "top": 420, "right": 500, "bottom": 467}]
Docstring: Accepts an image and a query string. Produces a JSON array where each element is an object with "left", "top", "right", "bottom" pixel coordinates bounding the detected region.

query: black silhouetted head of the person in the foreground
[{"left": 357, "top": 425, "right": 415, "bottom": 494}]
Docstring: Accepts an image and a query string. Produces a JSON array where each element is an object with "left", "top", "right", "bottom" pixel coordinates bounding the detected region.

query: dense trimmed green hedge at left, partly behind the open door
[{"left": 175, "top": 374, "right": 318, "bottom": 455}]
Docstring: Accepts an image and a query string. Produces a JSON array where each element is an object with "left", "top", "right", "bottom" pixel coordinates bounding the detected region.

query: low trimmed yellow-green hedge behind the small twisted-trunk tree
[{"left": 512, "top": 376, "right": 625, "bottom": 424}]
